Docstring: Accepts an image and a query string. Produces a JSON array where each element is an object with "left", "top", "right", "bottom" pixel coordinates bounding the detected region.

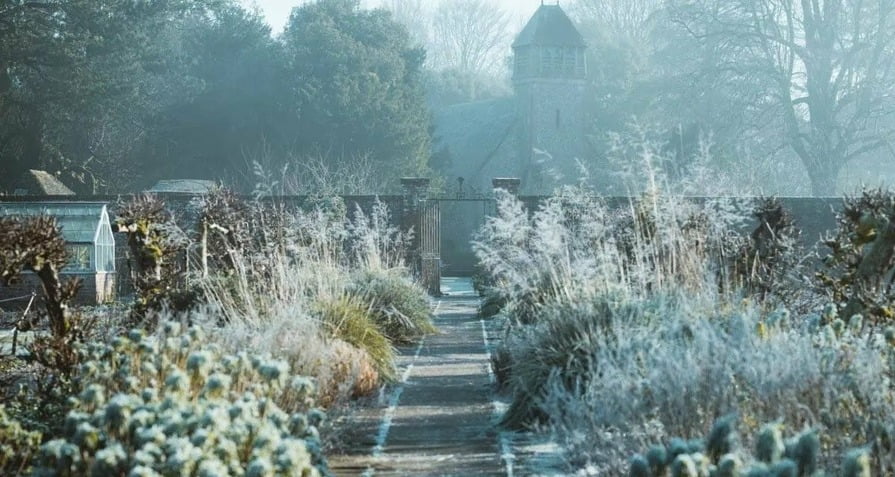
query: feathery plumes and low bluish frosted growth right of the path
[{"left": 475, "top": 184, "right": 895, "bottom": 475}]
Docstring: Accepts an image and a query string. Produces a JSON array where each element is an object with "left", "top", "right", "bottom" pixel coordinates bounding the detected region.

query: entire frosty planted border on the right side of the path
[{"left": 475, "top": 188, "right": 895, "bottom": 477}]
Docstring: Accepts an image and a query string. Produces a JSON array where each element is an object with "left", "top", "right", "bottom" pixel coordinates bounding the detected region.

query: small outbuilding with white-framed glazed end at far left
[{"left": 0, "top": 202, "right": 116, "bottom": 305}]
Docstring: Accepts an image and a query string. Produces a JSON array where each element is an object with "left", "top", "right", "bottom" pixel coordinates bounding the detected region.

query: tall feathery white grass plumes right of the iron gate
[{"left": 474, "top": 184, "right": 742, "bottom": 323}]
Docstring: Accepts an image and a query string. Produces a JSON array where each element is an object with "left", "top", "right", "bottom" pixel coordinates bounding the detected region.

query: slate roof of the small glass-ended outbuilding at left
[{"left": 0, "top": 202, "right": 110, "bottom": 243}]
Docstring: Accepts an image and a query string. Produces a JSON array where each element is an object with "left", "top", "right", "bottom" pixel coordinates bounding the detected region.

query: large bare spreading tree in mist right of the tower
[{"left": 670, "top": 0, "right": 895, "bottom": 195}]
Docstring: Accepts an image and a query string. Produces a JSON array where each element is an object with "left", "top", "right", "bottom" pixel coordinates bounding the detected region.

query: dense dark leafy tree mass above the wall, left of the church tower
[{"left": 0, "top": 0, "right": 429, "bottom": 193}]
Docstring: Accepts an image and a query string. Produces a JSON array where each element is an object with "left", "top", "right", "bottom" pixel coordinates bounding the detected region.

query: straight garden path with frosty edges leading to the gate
[{"left": 330, "top": 278, "right": 559, "bottom": 476}]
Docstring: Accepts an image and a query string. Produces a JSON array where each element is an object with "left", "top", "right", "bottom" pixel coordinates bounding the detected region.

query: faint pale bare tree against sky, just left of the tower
[{"left": 431, "top": 0, "right": 510, "bottom": 74}]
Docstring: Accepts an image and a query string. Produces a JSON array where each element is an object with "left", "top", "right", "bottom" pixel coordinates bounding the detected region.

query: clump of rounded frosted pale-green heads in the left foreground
[{"left": 34, "top": 325, "right": 327, "bottom": 476}]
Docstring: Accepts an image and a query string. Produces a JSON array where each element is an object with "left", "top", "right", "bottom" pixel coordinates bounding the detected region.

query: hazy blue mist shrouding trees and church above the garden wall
[{"left": 0, "top": 0, "right": 895, "bottom": 196}]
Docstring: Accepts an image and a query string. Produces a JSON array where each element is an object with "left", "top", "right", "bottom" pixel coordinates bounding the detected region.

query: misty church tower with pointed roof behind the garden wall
[{"left": 513, "top": 3, "right": 587, "bottom": 192}]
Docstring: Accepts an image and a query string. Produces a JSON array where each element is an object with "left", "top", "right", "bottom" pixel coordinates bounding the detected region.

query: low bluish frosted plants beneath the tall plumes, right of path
[{"left": 536, "top": 297, "right": 895, "bottom": 475}]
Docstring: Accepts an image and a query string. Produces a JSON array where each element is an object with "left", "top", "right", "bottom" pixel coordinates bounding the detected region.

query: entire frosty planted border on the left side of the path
[{"left": 0, "top": 190, "right": 435, "bottom": 476}]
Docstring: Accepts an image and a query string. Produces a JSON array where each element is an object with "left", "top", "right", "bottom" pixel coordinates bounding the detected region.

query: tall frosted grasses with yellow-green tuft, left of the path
[{"left": 202, "top": 197, "right": 432, "bottom": 406}]
